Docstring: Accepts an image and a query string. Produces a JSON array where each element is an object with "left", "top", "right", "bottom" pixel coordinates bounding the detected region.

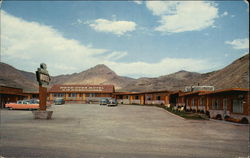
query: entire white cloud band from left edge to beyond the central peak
[{"left": 1, "top": 11, "right": 214, "bottom": 77}]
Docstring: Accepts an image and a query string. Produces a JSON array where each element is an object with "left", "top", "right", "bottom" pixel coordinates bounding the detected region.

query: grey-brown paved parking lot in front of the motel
[{"left": 0, "top": 104, "right": 249, "bottom": 158}]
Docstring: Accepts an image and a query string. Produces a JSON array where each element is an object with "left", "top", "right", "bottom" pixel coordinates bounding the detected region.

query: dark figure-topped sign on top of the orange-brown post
[{"left": 36, "top": 63, "right": 51, "bottom": 87}]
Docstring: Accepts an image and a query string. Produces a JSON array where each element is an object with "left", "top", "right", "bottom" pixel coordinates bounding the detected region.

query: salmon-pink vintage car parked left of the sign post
[{"left": 5, "top": 99, "right": 39, "bottom": 110}]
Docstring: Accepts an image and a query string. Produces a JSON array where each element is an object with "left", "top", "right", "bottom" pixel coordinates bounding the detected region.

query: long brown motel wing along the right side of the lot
[{"left": 177, "top": 88, "right": 250, "bottom": 122}]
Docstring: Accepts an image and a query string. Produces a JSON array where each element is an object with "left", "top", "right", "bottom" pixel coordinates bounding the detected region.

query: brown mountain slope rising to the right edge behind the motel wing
[{"left": 122, "top": 54, "right": 249, "bottom": 92}]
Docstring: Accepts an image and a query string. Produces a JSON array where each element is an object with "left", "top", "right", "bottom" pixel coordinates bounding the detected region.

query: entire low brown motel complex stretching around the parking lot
[{"left": 0, "top": 85, "right": 250, "bottom": 122}]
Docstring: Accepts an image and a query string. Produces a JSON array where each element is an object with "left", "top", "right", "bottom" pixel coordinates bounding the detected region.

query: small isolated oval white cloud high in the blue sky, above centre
[{"left": 88, "top": 19, "right": 136, "bottom": 36}]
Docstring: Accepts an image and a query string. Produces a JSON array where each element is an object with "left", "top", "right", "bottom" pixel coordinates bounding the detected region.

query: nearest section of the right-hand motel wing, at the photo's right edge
[{"left": 199, "top": 88, "right": 250, "bottom": 121}]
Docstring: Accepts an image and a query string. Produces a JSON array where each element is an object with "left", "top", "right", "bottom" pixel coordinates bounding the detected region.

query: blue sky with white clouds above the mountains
[{"left": 1, "top": 1, "right": 249, "bottom": 78}]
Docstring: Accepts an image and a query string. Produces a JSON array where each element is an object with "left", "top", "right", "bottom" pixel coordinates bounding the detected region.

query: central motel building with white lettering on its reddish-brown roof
[{"left": 48, "top": 85, "right": 115, "bottom": 103}]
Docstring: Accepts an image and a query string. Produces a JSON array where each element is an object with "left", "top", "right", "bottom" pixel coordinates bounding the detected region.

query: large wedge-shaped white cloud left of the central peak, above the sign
[{"left": 1, "top": 11, "right": 108, "bottom": 74}]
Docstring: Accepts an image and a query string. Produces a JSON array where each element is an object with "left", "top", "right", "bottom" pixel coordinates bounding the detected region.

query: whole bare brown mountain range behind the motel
[{"left": 0, "top": 54, "right": 249, "bottom": 92}]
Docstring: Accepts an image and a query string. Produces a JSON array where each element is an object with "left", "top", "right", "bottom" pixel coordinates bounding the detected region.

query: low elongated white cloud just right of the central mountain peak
[{"left": 105, "top": 58, "right": 215, "bottom": 77}]
